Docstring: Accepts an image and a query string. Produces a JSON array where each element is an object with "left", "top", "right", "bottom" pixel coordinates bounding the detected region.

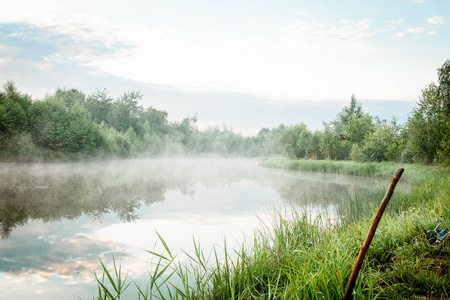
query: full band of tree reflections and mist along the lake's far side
[{"left": 0, "top": 159, "right": 386, "bottom": 238}]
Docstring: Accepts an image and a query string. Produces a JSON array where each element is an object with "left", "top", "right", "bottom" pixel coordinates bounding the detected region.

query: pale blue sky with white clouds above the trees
[{"left": 0, "top": 0, "right": 450, "bottom": 134}]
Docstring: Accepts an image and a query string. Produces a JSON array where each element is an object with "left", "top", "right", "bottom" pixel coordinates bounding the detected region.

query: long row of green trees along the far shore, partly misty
[{"left": 0, "top": 60, "right": 450, "bottom": 163}]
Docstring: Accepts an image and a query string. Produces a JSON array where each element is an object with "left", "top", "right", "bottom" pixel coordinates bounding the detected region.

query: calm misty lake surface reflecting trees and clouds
[{"left": 0, "top": 158, "right": 389, "bottom": 299}]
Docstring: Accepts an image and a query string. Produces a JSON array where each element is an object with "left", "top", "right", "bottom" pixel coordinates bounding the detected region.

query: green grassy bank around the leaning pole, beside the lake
[{"left": 93, "top": 161, "right": 450, "bottom": 299}]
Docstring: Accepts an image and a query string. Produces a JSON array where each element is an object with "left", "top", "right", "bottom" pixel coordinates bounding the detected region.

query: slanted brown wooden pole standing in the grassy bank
[{"left": 343, "top": 169, "right": 405, "bottom": 300}]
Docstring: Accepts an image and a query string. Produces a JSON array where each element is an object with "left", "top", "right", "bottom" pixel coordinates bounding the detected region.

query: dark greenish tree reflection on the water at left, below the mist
[{"left": 0, "top": 174, "right": 166, "bottom": 238}]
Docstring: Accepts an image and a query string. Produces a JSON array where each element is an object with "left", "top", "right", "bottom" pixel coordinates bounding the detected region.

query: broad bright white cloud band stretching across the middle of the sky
[{"left": 0, "top": 11, "right": 428, "bottom": 102}]
